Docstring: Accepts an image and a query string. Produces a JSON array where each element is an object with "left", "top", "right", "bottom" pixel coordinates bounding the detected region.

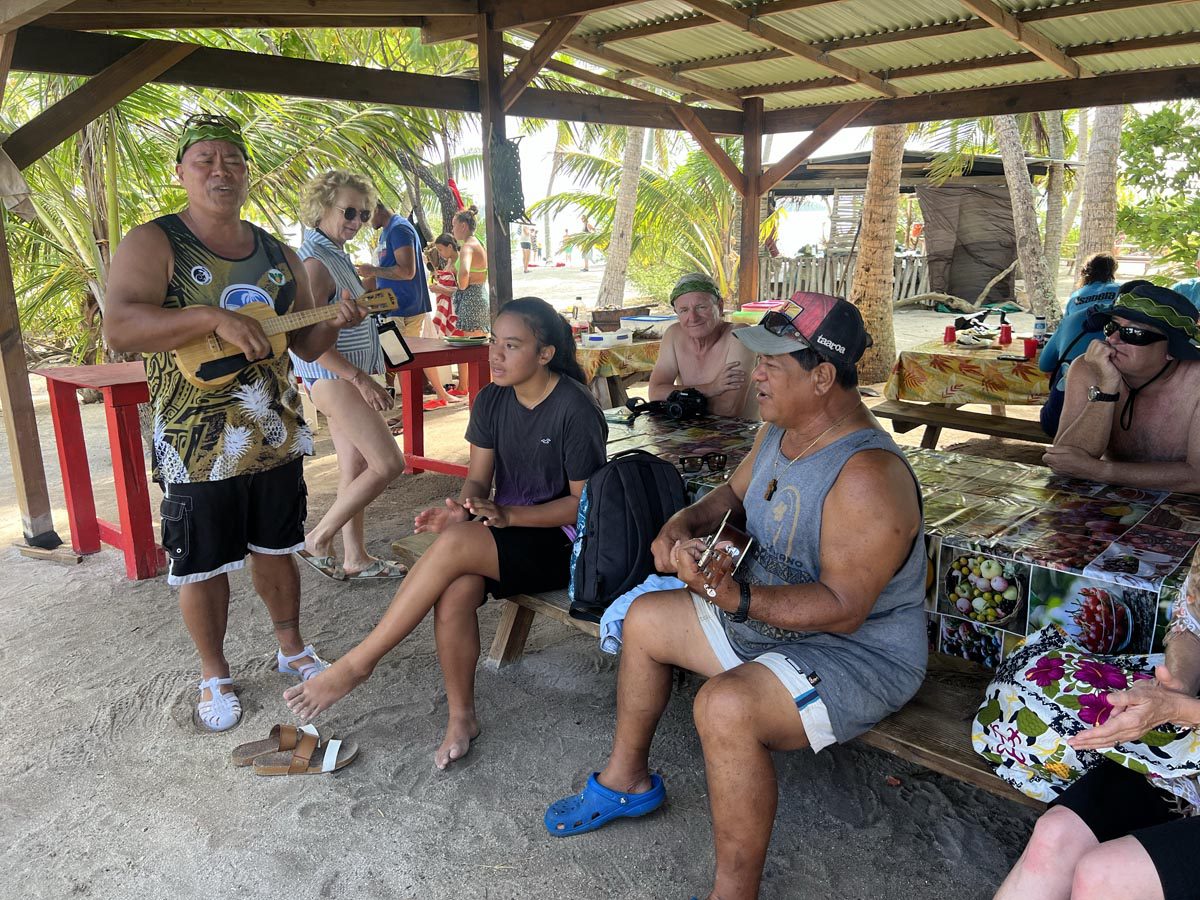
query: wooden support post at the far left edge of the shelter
[{"left": 0, "top": 32, "right": 62, "bottom": 550}]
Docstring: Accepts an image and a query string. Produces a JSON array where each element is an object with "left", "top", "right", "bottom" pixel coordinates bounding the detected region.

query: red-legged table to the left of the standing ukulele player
[{"left": 35, "top": 362, "right": 167, "bottom": 580}]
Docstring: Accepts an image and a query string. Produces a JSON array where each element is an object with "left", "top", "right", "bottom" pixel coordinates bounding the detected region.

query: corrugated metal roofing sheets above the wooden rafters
[{"left": 556, "top": 0, "right": 1200, "bottom": 109}]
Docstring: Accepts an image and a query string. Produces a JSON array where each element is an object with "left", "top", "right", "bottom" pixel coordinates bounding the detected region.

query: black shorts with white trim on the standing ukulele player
[{"left": 162, "top": 457, "right": 308, "bottom": 586}]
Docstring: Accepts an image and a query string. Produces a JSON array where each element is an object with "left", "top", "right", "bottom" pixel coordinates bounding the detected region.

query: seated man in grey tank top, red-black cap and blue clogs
[{"left": 545, "top": 293, "right": 928, "bottom": 898}]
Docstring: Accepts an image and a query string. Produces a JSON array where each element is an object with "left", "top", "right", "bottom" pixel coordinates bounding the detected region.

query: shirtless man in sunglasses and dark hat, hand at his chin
[{"left": 1043, "top": 280, "right": 1200, "bottom": 493}]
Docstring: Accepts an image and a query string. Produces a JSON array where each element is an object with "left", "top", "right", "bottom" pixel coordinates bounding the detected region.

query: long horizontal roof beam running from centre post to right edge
[{"left": 763, "top": 63, "right": 1200, "bottom": 133}]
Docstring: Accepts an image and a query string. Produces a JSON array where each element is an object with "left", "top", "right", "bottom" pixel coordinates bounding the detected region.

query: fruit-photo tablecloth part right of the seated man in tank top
[{"left": 906, "top": 449, "right": 1200, "bottom": 667}]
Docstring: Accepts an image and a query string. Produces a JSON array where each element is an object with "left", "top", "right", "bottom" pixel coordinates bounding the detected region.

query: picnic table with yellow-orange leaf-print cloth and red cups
[{"left": 871, "top": 341, "right": 1051, "bottom": 449}]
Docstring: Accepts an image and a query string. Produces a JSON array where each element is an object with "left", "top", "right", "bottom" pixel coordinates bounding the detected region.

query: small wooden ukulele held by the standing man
[{"left": 170, "top": 288, "right": 396, "bottom": 390}]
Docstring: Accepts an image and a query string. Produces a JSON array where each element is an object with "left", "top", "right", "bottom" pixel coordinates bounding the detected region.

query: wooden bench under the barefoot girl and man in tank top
[{"left": 392, "top": 534, "right": 1043, "bottom": 809}]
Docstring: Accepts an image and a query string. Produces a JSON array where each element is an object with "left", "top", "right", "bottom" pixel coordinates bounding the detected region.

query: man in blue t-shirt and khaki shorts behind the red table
[{"left": 355, "top": 200, "right": 461, "bottom": 415}]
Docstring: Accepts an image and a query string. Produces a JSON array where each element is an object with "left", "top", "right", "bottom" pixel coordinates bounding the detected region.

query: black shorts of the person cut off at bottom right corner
[{"left": 1050, "top": 760, "right": 1200, "bottom": 900}]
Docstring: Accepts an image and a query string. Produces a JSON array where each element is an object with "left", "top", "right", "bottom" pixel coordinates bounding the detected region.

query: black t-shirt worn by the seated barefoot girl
[{"left": 467, "top": 376, "right": 608, "bottom": 506}]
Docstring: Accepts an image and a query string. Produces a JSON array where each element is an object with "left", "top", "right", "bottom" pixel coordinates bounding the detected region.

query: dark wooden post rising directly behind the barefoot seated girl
[{"left": 476, "top": 16, "right": 512, "bottom": 319}]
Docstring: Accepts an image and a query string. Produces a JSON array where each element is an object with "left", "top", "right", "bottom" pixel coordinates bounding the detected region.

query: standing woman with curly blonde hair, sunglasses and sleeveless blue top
[{"left": 292, "top": 169, "right": 406, "bottom": 578}]
